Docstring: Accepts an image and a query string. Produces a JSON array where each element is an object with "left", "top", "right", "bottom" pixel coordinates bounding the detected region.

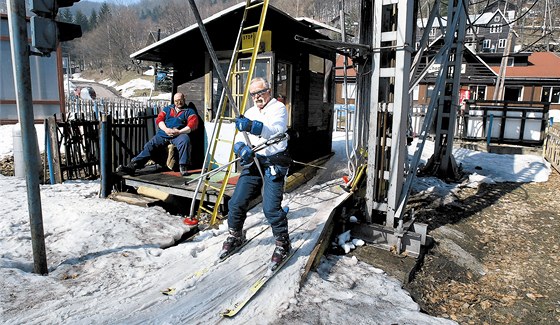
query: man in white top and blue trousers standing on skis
[{"left": 220, "top": 78, "right": 292, "bottom": 268}]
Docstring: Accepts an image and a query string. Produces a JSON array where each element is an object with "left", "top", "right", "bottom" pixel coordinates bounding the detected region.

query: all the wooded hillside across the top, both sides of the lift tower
[{"left": 0, "top": 0, "right": 560, "bottom": 80}]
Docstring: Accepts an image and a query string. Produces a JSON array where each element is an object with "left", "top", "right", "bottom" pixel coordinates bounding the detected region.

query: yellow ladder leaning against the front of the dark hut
[{"left": 191, "top": 0, "right": 269, "bottom": 225}]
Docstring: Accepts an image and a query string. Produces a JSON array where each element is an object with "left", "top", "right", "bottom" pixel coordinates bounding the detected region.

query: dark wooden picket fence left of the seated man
[{"left": 46, "top": 98, "right": 169, "bottom": 183}]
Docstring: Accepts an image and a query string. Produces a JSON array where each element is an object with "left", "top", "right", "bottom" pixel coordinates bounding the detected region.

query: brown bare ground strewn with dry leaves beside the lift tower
[{"left": 355, "top": 171, "right": 560, "bottom": 324}]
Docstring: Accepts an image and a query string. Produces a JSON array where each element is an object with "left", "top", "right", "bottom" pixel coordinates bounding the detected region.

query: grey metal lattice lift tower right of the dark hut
[{"left": 351, "top": 0, "right": 468, "bottom": 256}]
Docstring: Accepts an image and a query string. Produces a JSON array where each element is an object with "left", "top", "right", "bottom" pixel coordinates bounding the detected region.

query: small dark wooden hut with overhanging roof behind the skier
[{"left": 131, "top": 3, "right": 335, "bottom": 163}]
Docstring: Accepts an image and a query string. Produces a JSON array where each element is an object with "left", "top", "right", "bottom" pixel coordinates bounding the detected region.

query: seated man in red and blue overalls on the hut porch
[{"left": 117, "top": 93, "right": 199, "bottom": 176}]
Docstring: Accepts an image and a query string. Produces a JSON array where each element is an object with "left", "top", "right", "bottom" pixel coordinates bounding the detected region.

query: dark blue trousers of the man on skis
[{"left": 228, "top": 164, "right": 288, "bottom": 238}]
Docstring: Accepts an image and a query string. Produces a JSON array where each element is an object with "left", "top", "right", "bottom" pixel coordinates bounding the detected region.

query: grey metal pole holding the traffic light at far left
[{"left": 8, "top": 0, "right": 48, "bottom": 274}]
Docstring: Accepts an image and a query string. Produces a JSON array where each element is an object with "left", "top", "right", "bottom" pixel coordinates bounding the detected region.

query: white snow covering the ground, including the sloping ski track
[{"left": 0, "top": 106, "right": 550, "bottom": 324}]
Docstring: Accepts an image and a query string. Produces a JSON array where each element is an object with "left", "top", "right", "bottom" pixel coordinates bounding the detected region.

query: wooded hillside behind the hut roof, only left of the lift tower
[{"left": 55, "top": 0, "right": 360, "bottom": 79}]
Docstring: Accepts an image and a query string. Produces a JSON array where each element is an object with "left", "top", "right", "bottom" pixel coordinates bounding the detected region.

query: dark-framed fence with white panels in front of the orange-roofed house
[{"left": 410, "top": 101, "right": 549, "bottom": 145}]
